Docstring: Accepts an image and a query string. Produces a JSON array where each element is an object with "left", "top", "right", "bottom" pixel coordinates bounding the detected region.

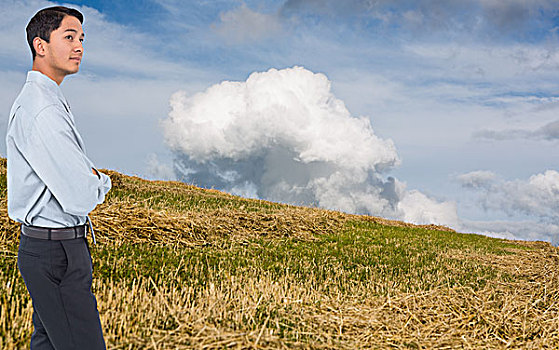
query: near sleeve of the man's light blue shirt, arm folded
[{"left": 21, "top": 105, "right": 111, "bottom": 216}]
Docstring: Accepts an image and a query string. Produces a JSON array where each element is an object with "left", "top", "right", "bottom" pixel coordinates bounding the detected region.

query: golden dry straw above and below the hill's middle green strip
[{"left": 0, "top": 161, "right": 559, "bottom": 349}]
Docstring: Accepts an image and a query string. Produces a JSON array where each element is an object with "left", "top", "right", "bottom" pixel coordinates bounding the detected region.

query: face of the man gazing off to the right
[{"left": 45, "top": 16, "right": 84, "bottom": 78}]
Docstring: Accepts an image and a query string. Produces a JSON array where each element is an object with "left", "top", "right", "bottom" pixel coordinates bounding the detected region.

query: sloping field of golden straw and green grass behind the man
[{"left": 0, "top": 159, "right": 559, "bottom": 349}]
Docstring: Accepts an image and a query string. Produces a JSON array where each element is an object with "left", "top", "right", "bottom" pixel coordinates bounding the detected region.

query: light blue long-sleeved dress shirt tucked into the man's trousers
[{"left": 6, "top": 71, "right": 111, "bottom": 232}]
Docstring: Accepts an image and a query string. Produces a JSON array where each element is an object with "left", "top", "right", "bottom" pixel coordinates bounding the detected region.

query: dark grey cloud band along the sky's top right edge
[{"left": 281, "top": 0, "right": 559, "bottom": 41}]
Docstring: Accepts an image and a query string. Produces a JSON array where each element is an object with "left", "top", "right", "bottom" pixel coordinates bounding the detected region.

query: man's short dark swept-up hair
[{"left": 25, "top": 6, "right": 83, "bottom": 59}]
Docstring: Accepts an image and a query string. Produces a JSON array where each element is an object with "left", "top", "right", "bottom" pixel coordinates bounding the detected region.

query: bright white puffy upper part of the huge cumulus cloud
[{"left": 164, "top": 67, "right": 398, "bottom": 171}]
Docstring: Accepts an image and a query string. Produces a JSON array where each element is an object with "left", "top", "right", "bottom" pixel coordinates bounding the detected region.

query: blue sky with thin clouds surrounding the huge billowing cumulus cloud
[{"left": 0, "top": 0, "right": 559, "bottom": 241}]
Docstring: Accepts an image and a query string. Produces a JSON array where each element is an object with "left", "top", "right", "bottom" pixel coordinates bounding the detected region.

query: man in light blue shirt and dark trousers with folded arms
[{"left": 6, "top": 6, "right": 111, "bottom": 350}]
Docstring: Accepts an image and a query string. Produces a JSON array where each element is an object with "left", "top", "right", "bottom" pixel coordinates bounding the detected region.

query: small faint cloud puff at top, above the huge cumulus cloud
[{"left": 213, "top": 3, "right": 283, "bottom": 44}]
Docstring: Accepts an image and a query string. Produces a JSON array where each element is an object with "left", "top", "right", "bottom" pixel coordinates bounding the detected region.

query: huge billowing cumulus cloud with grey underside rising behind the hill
[{"left": 162, "top": 67, "right": 457, "bottom": 224}]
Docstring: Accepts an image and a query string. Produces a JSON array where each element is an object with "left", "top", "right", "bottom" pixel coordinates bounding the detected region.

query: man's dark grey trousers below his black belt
[{"left": 17, "top": 235, "right": 106, "bottom": 350}]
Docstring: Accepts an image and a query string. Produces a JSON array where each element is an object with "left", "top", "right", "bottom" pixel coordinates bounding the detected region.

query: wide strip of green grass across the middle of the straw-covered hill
[{"left": 94, "top": 221, "right": 511, "bottom": 294}]
